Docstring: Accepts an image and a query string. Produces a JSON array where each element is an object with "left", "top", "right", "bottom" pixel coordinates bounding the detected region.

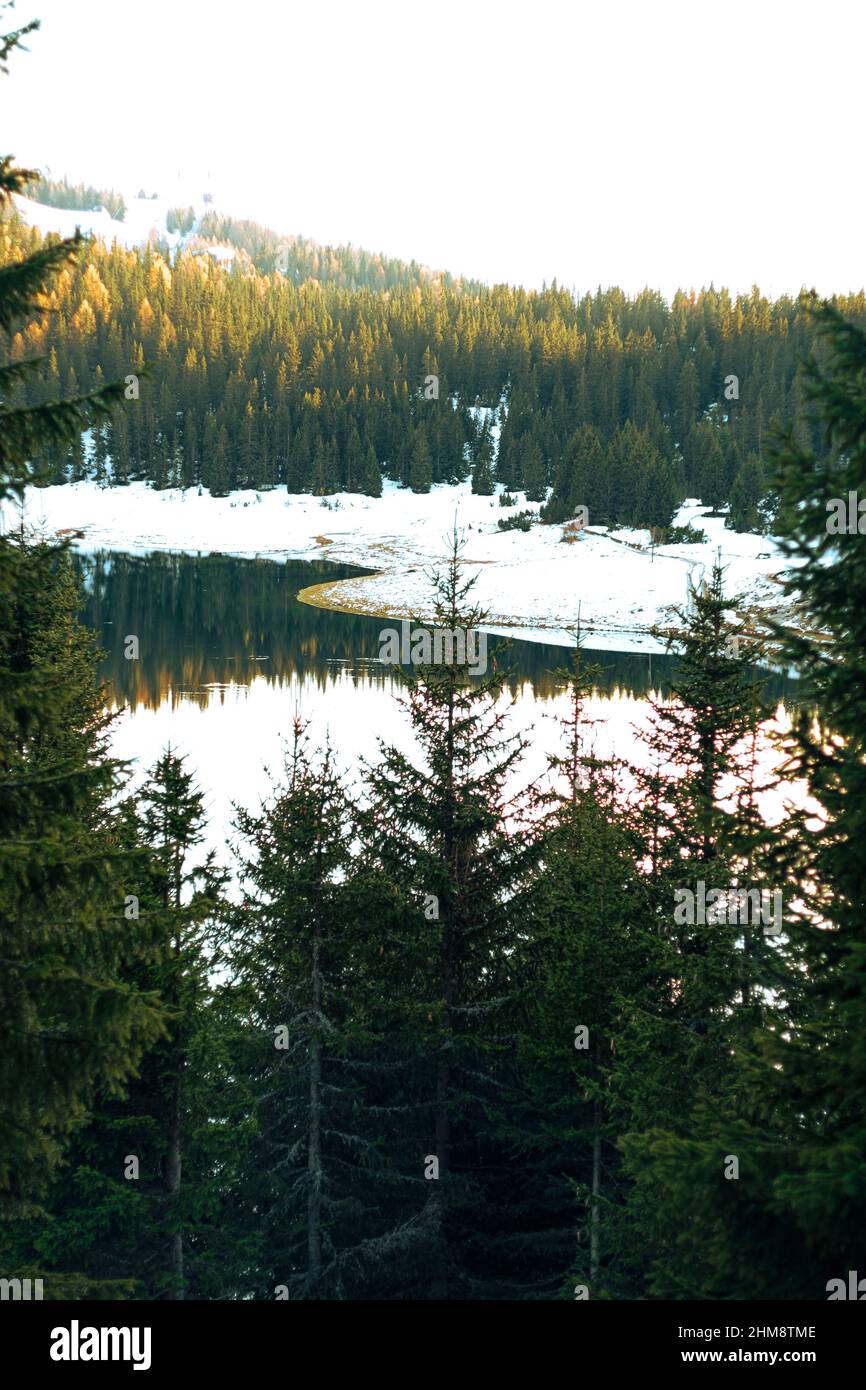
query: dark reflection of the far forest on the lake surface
[{"left": 75, "top": 552, "right": 791, "bottom": 710}]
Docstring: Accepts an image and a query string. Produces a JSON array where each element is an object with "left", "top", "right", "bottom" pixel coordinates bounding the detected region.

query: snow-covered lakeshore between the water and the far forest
[{"left": 0, "top": 482, "right": 785, "bottom": 652}]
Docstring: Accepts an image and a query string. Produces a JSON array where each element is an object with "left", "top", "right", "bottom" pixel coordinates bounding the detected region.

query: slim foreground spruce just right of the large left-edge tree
[{"left": 5, "top": 751, "right": 226, "bottom": 1300}]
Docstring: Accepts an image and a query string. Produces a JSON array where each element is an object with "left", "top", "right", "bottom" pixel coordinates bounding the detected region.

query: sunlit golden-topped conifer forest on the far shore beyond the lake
[{"left": 0, "top": 198, "right": 866, "bottom": 530}]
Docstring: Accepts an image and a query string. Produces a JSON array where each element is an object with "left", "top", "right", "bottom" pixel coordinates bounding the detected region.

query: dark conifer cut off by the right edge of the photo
[{"left": 686, "top": 303, "right": 866, "bottom": 1298}]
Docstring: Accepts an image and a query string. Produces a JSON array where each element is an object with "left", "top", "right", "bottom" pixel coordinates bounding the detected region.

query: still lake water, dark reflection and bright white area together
[{"left": 76, "top": 552, "right": 790, "bottom": 862}]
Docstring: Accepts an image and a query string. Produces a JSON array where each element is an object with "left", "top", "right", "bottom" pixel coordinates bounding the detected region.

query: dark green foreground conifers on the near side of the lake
[{"left": 0, "top": 472, "right": 866, "bottom": 1300}]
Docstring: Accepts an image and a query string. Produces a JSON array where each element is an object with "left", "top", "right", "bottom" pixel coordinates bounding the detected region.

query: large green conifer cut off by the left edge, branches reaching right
[{"left": 0, "top": 16, "right": 161, "bottom": 1211}]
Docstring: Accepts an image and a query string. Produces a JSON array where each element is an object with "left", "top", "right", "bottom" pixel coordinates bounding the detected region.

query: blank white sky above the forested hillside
[{"left": 0, "top": 0, "right": 866, "bottom": 296}]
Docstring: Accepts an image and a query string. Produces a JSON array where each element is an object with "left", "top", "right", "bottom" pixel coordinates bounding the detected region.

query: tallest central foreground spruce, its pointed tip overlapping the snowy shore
[{"left": 360, "top": 537, "right": 535, "bottom": 1298}]
